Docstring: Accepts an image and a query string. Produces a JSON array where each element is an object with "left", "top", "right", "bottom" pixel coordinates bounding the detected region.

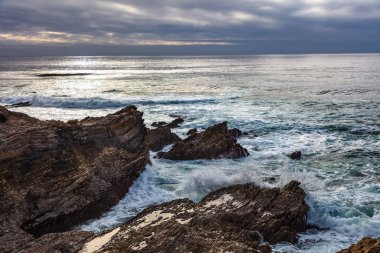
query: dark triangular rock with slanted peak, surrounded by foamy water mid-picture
[{"left": 157, "top": 122, "right": 249, "bottom": 160}]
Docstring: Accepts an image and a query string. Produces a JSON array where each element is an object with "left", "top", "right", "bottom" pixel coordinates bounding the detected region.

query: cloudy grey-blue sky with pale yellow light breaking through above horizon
[{"left": 0, "top": 0, "right": 380, "bottom": 56}]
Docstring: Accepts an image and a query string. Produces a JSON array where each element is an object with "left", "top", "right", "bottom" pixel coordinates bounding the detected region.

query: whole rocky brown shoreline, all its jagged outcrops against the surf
[{"left": 0, "top": 106, "right": 379, "bottom": 253}]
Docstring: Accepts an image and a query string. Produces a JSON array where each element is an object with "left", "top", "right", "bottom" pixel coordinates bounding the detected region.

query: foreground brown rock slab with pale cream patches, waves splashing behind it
[{"left": 20, "top": 181, "right": 308, "bottom": 253}]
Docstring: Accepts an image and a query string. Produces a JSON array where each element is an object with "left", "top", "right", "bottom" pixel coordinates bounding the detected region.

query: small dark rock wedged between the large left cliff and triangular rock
[{"left": 146, "top": 127, "right": 181, "bottom": 151}]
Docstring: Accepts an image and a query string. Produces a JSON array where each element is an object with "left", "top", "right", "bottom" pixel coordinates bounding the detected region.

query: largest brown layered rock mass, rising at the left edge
[{"left": 0, "top": 106, "right": 149, "bottom": 252}]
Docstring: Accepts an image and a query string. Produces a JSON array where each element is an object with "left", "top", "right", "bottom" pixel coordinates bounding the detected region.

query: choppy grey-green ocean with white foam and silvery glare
[{"left": 0, "top": 54, "right": 380, "bottom": 253}]
